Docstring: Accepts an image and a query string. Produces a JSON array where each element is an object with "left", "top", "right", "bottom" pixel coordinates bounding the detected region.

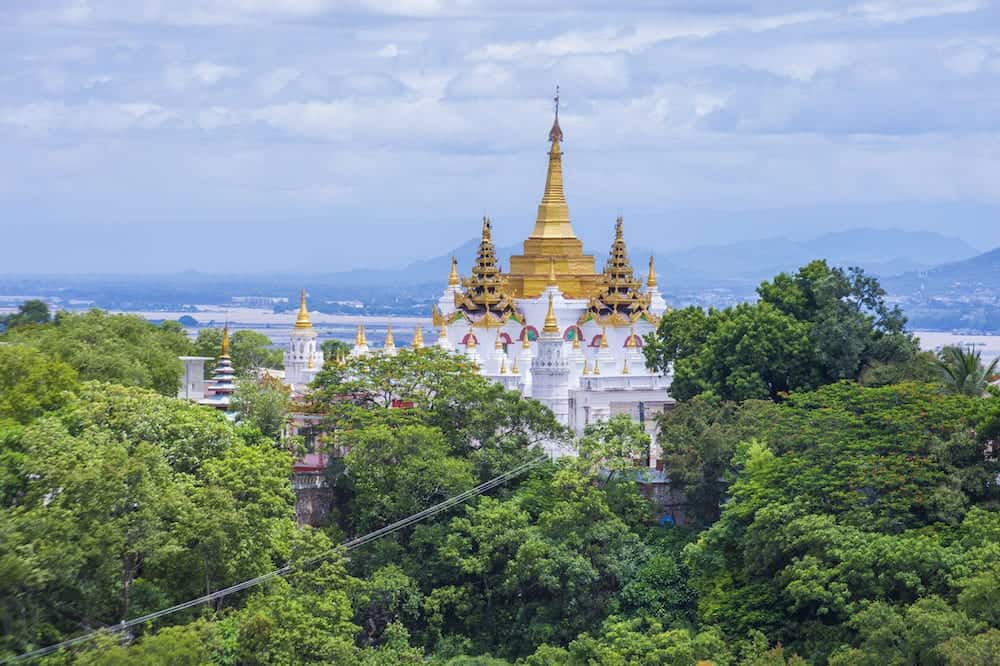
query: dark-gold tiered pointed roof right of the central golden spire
[{"left": 579, "top": 215, "right": 656, "bottom": 326}]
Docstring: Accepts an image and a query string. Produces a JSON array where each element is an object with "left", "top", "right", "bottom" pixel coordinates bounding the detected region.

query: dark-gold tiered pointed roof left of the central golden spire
[{"left": 452, "top": 217, "right": 523, "bottom": 327}]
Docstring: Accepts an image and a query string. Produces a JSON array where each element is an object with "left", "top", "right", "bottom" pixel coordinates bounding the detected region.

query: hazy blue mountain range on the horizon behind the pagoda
[{"left": 329, "top": 229, "right": 977, "bottom": 288}]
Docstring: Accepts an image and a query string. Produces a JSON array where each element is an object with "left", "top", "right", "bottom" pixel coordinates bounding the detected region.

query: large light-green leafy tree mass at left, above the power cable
[{"left": 0, "top": 383, "right": 295, "bottom": 654}]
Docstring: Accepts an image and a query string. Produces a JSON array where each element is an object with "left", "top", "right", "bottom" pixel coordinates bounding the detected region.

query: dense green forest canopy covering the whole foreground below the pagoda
[{"left": 0, "top": 262, "right": 1000, "bottom": 666}]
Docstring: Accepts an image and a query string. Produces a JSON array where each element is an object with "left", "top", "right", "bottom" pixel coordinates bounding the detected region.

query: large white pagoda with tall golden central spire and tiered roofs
[{"left": 352, "top": 99, "right": 674, "bottom": 460}]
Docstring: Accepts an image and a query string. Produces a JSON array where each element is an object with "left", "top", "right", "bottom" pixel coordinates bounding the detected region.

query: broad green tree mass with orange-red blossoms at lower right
[{"left": 685, "top": 382, "right": 1000, "bottom": 663}]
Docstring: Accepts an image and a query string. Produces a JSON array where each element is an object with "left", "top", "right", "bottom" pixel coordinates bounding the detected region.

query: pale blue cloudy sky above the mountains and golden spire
[{"left": 0, "top": 0, "right": 1000, "bottom": 272}]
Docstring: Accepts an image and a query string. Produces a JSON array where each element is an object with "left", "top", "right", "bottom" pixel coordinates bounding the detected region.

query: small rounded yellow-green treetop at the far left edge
[{"left": 0, "top": 345, "right": 79, "bottom": 423}]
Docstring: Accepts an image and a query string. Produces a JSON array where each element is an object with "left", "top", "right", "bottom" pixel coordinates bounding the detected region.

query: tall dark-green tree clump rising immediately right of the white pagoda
[{"left": 644, "top": 261, "right": 917, "bottom": 401}]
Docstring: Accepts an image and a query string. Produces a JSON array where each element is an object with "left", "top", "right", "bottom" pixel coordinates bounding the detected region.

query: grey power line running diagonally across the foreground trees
[{"left": 0, "top": 448, "right": 549, "bottom": 664}]
